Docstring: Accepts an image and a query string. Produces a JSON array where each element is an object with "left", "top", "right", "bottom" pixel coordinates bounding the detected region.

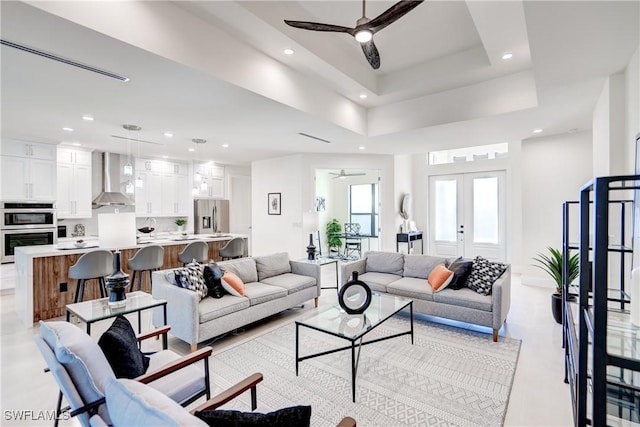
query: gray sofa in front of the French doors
[{"left": 340, "top": 252, "right": 511, "bottom": 341}]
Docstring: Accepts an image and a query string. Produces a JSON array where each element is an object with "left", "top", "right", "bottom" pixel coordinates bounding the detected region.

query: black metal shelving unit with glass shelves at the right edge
[{"left": 562, "top": 175, "right": 640, "bottom": 426}]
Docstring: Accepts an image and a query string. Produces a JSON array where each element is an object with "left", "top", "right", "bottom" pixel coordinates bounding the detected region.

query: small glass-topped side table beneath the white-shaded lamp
[{"left": 66, "top": 291, "right": 167, "bottom": 338}]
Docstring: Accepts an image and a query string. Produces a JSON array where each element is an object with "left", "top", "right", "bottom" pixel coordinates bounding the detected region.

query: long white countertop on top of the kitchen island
[{"left": 15, "top": 233, "right": 248, "bottom": 258}]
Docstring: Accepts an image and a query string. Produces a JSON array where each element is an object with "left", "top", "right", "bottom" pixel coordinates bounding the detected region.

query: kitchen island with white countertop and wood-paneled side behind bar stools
[{"left": 15, "top": 234, "right": 248, "bottom": 328}]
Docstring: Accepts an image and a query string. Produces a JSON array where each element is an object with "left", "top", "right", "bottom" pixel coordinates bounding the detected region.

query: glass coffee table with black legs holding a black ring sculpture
[{"left": 296, "top": 293, "right": 413, "bottom": 402}]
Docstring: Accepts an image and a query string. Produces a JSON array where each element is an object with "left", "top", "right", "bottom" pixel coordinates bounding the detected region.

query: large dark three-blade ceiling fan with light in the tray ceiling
[{"left": 284, "top": 0, "right": 424, "bottom": 70}]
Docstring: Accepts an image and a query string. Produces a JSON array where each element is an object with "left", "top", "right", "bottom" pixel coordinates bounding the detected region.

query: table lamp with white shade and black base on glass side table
[{"left": 98, "top": 210, "right": 136, "bottom": 308}]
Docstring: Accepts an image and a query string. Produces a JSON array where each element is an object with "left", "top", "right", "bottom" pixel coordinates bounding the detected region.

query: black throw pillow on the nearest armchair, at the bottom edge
[{"left": 194, "top": 406, "right": 311, "bottom": 427}]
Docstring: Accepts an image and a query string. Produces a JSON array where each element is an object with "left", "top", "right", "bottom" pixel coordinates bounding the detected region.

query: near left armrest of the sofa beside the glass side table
[{"left": 151, "top": 270, "right": 200, "bottom": 344}]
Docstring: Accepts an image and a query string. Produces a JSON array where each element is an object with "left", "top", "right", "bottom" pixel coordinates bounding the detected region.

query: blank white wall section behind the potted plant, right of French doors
[{"left": 520, "top": 132, "right": 593, "bottom": 287}]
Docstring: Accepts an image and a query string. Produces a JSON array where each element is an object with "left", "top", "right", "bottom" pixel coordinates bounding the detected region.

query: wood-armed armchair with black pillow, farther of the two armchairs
[{"left": 34, "top": 321, "right": 212, "bottom": 426}]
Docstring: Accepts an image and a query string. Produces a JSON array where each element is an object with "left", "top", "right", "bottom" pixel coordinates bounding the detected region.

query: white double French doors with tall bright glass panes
[{"left": 429, "top": 171, "right": 506, "bottom": 261}]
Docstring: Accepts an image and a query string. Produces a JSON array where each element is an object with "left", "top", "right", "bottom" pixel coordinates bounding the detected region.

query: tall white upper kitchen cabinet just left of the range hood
[{"left": 56, "top": 147, "right": 91, "bottom": 219}]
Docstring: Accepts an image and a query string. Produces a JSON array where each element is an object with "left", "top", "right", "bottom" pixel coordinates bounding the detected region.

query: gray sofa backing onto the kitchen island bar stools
[{"left": 151, "top": 253, "right": 321, "bottom": 351}]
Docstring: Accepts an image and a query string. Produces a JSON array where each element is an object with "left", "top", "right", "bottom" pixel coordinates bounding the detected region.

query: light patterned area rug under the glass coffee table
[{"left": 211, "top": 316, "right": 520, "bottom": 427}]
